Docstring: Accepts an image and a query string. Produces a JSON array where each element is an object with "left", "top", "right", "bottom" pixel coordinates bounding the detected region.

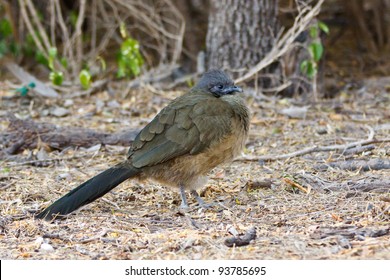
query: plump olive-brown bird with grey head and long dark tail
[{"left": 35, "top": 69, "right": 250, "bottom": 221}]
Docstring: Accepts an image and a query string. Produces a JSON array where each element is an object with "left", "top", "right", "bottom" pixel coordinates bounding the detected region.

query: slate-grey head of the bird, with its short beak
[{"left": 194, "top": 70, "right": 242, "bottom": 98}]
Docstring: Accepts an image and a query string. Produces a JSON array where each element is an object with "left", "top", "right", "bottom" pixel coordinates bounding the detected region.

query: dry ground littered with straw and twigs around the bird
[{"left": 0, "top": 69, "right": 390, "bottom": 259}]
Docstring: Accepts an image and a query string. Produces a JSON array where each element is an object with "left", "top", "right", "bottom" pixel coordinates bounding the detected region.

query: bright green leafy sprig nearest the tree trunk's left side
[{"left": 117, "top": 24, "right": 144, "bottom": 78}]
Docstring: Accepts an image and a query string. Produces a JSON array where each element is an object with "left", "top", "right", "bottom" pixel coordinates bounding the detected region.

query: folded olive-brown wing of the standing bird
[{"left": 129, "top": 98, "right": 233, "bottom": 168}]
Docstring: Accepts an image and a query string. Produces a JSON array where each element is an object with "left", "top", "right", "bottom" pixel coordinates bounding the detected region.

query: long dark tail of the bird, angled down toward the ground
[{"left": 36, "top": 162, "right": 141, "bottom": 220}]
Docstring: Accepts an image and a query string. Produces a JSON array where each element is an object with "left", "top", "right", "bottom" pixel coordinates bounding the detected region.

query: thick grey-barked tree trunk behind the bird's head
[{"left": 206, "top": 0, "right": 279, "bottom": 81}]
